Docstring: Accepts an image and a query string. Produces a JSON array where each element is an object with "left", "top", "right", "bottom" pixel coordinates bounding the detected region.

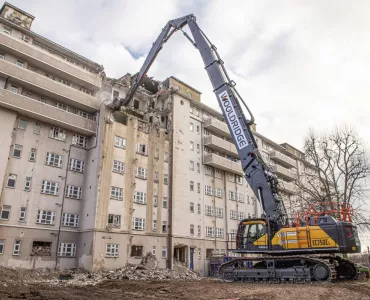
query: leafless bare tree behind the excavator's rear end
[{"left": 296, "top": 126, "right": 370, "bottom": 223}]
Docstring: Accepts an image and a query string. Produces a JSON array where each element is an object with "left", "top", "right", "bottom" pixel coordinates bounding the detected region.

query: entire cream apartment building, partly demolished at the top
[{"left": 0, "top": 3, "right": 312, "bottom": 275}]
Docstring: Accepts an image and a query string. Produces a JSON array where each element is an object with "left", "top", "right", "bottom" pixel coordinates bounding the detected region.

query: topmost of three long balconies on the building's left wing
[{"left": 0, "top": 33, "right": 101, "bottom": 90}]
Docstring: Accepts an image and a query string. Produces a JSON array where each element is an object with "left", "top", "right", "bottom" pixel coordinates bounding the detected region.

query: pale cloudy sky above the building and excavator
[{"left": 9, "top": 0, "right": 370, "bottom": 149}]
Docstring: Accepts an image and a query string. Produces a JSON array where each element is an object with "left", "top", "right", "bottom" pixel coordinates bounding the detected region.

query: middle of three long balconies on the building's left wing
[{"left": 0, "top": 59, "right": 100, "bottom": 112}]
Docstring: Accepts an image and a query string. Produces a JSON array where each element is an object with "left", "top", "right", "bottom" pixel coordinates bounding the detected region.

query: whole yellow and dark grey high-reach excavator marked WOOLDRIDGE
[{"left": 116, "top": 15, "right": 360, "bottom": 282}]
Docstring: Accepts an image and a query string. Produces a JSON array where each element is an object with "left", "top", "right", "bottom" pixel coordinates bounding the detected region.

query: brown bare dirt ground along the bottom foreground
[{"left": 0, "top": 277, "right": 370, "bottom": 300}]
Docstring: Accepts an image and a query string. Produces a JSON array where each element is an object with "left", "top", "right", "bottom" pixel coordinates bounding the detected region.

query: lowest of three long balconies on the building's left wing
[{"left": 0, "top": 89, "right": 96, "bottom": 136}]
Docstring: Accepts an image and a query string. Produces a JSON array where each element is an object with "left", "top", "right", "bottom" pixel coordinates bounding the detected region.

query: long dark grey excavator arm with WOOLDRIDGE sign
[{"left": 119, "top": 15, "right": 286, "bottom": 225}]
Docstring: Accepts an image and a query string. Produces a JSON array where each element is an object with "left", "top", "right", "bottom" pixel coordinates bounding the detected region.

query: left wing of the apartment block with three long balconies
[{"left": 0, "top": 3, "right": 103, "bottom": 268}]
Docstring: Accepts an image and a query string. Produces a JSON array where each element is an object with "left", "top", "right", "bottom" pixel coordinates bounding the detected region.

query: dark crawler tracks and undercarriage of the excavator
[{"left": 218, "top": 255, "right": 359, "bottom": 283}]
